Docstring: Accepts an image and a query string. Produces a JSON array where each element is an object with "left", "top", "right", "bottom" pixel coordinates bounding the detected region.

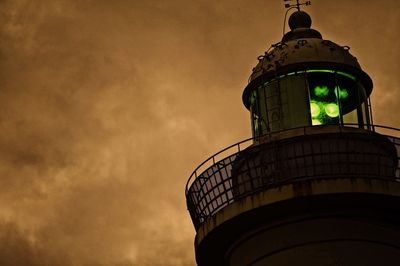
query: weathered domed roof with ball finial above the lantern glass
[{"left": 243, "top": 11, "right": 372, "bottom": 108}]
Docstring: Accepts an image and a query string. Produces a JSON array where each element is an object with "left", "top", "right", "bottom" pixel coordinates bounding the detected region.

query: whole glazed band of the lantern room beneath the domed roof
[{"left": 249, "top": 70, "right": 370, "bottom": 137}]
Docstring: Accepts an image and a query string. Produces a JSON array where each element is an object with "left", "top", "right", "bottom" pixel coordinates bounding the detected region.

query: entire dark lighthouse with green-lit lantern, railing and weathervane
[{"left": 186, "top": 1, "right": 400, "bottom": 266}]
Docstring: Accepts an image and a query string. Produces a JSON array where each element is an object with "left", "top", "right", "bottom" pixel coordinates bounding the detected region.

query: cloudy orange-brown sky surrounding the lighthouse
[{"left": 0, "top": 0, "right": 400, "bottom": 266}]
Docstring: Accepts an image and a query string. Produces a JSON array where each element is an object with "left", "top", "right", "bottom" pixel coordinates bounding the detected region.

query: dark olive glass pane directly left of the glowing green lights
[{"left": 280, "top": 73, "right": 310, "bottom": 129}]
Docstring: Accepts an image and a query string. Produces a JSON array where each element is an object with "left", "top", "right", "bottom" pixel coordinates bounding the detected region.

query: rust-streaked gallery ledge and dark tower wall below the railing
[{"left": 196, "top": 179, "right": 400, "bottom": 266}]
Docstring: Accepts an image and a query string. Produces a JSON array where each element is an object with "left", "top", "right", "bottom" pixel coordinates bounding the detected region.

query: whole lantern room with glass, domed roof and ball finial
[{"left": 243, "top": 11, "right": 372, "bottom": 137}]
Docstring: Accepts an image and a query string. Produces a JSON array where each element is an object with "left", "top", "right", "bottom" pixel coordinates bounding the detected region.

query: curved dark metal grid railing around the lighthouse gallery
[{"left": 186, "top": 125, "right": 400, "bottom": 228}]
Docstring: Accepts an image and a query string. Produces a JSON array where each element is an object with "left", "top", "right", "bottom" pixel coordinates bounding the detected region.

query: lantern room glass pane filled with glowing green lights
[{"left": 307, "top": 71, "right": 340, "bottom": 126}]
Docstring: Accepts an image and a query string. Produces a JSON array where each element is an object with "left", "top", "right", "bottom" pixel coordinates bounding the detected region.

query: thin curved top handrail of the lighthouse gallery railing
[{"left": 185, "top": 123, "right": 400, "bottom": 195}]
